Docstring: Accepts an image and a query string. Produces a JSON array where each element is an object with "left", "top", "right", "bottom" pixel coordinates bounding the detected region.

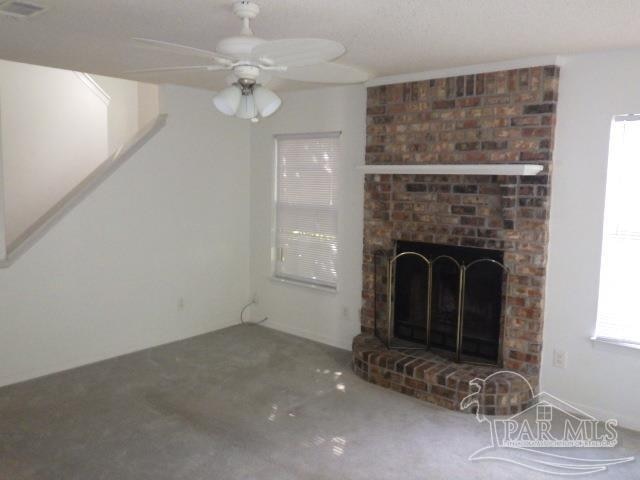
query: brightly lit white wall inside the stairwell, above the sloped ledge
[{"left": 0, "top": 60, "right": 108, "bottom": 245}]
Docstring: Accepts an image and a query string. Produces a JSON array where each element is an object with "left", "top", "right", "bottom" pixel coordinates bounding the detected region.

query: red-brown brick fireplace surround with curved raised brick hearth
[{"left": 353, "top": 66, "right": 559, "bottom": 414}]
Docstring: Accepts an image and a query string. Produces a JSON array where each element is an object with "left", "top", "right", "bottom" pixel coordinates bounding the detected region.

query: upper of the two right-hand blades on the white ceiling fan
[{"left": 251, "top": 38, "right": 345, "bottom": 67}]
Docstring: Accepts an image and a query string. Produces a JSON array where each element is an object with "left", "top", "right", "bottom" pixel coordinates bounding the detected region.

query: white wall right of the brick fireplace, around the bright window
[{"left": 542, "top": 51, "right": 640, "bottom": 429}]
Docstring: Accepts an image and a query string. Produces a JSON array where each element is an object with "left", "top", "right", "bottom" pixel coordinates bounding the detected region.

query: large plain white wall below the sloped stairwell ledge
[{"left": 0, "top": 87, "right": 249, "bottom": 385}]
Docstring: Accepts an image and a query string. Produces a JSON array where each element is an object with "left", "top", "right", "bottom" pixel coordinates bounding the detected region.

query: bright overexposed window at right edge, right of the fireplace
[{"left": 596, "top": 115, "right": 640, "bottom": 345}]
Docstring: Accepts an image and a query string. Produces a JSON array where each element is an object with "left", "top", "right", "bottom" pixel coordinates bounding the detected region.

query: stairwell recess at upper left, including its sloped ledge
[{"left": 0, "top": 60, "right": 166, "bottom": 268}]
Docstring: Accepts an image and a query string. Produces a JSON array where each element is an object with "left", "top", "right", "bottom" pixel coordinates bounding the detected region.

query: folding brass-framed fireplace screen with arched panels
[{"left": 375, "top": 251, "right": 509, "bottom": 365}]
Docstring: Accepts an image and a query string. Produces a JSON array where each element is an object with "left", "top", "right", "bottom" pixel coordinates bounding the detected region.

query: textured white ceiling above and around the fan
[{"left": 0, "top": 0, "right": 640, "bottom": 90}]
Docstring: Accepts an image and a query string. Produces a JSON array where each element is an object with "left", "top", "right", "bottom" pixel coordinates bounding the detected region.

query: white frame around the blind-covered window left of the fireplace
[{"left": 271, "top": 130, "right": 342, "bottom": 293}]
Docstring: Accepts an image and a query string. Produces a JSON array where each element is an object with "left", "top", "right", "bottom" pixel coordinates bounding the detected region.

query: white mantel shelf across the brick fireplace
[{"left": 357, "top": 163, "right": 544, "bottom": 176}]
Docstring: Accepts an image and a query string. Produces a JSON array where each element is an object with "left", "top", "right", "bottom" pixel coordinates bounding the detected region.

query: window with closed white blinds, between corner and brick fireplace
[{"left": 275, "top": 133, "right": 340, "bottom": 288}]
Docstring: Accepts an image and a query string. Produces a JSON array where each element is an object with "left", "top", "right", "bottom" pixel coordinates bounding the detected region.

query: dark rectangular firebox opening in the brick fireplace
[{"left": 393, "top": 241, "right": 506, "bottom": 364}]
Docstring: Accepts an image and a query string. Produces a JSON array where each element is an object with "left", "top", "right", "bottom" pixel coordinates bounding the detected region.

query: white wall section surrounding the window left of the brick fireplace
[{"left": 251, "top": 85, "right": 366, "bottom": 348}]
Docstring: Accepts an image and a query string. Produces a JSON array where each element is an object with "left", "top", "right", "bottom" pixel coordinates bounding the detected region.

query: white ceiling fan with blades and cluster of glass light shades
[{"left": 124, "top": 0, "right": 368, "bottom": 122}]
